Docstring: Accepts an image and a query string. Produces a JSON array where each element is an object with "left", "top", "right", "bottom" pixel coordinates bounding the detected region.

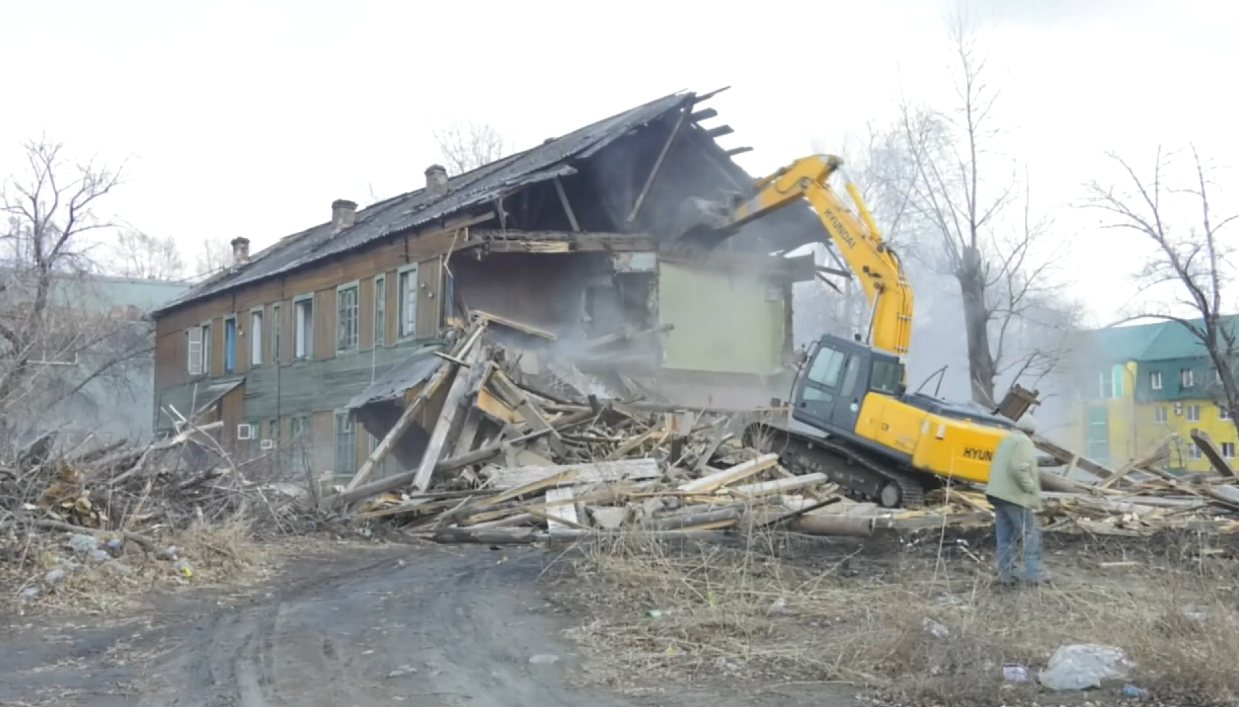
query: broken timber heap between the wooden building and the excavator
[{"left": 321, "top": 313, "right": 901, "bottom": 544}]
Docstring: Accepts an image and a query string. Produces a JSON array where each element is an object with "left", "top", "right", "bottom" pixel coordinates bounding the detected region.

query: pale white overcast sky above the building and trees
[{"left": 0, "top": 0, "right": 1239, "bottom": 321}]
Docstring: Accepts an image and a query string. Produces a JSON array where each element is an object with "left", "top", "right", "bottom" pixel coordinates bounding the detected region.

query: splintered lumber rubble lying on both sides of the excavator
[{"left": 321, "top": 312, "right": 1239, "bottom": 544}]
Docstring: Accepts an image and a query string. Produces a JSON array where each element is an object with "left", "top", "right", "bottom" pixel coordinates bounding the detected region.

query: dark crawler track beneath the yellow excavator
[{"left": 745, "top": 423, "right": 932, "bottom": 509}]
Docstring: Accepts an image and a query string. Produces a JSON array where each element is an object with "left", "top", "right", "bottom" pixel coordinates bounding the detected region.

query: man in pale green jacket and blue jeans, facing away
[{"left": 985, "top": 415, "right": 1047, "bottom": 586}]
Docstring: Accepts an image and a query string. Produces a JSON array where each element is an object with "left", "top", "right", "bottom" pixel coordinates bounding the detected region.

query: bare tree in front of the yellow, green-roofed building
[{"left": 1087, "top": 146, "right": 1239, "bottom": 431}]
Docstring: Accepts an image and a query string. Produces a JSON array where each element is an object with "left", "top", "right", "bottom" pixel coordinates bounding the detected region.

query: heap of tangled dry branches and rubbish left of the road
[{"left": 0, "top": 411, "right": 310, "bottom": 599}]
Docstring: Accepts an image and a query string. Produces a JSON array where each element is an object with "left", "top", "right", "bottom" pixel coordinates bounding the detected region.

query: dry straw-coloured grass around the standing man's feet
[{"left": 557, "top": 536, "right": 1239, "bottom": 705}]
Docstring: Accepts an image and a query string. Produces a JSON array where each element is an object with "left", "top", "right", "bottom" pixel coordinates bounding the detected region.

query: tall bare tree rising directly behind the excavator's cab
[{"left": 898, "top": 14, "right": 1067, "bottom": 406}]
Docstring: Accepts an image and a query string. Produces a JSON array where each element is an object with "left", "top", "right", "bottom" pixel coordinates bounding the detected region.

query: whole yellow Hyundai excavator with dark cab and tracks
[{"left": 667, "top": 155, "right": 1012, "bottom": 508}]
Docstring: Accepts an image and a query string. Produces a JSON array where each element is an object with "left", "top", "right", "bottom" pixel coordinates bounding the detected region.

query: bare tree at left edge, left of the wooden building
[{"left": 0, "top": 140, "right": 152, "bottom": 442}]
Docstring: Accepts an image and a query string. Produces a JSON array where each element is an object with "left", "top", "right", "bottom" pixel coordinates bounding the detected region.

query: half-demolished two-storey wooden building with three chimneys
[{"left": 155, "top": 87, "right": 824, "bottom": 474}]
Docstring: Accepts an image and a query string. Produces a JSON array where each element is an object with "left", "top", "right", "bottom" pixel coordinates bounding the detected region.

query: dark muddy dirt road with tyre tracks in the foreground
[{"left": 0, "top": 546, "right": 851, "bottom": 707}]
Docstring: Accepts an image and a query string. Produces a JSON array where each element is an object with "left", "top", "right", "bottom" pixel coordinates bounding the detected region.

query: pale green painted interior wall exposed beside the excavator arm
[{"left": 658, "top": 261, "right": 788, "bottom": 375}]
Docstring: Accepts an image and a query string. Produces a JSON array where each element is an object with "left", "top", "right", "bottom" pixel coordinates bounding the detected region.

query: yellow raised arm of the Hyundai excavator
[{"left": 674, "top": 155, "right": 913, "bottom": 357}]
